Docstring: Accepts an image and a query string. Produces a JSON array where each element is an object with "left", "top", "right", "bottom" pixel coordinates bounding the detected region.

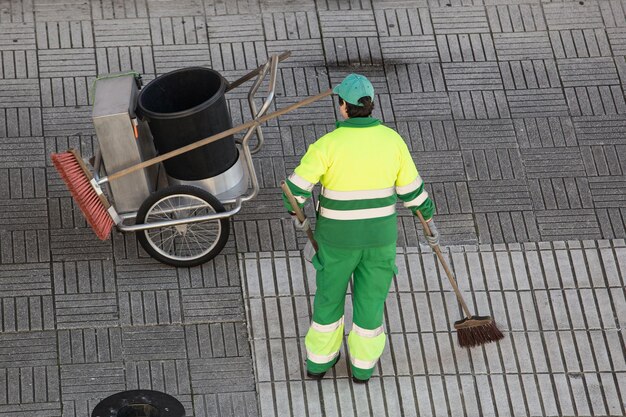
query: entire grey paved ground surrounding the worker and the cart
[{"left": 0, "top": 0, "right": 626, "bottom": 417}]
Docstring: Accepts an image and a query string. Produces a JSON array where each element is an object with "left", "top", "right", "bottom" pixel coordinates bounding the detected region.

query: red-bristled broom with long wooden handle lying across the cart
[{"left": 50, "top": 86, "right": 332, "bottom": 240}]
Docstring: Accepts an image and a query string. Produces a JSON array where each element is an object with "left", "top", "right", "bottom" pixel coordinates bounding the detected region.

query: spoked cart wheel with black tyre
[{"left": 137, "top": 185, "right": 230, "bottom": 267}]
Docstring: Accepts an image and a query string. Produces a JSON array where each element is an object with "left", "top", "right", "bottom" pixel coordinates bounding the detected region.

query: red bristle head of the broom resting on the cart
[{"left": 50, "top": 151, "right": 113, "bottom": 240}]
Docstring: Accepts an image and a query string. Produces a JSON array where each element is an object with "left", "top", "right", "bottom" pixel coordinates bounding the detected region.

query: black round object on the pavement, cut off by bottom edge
[{"left": 91, "top": 389, "right": 185, "bottom": 417}]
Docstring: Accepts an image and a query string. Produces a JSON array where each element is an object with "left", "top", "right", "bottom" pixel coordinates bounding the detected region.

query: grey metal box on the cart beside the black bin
[{"left": 92, "top": 74, "right": 158, "bottom": 213}]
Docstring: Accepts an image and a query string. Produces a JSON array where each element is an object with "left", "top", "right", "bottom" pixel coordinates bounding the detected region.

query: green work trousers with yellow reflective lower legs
[{"left": 305, "top": 242, "right": 397, "bottom": 379}]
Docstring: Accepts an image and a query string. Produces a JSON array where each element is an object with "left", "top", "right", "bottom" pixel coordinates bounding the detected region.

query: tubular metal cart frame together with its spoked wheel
[{"left": 93, "top": 52, "right": 280, "bottom": 267}]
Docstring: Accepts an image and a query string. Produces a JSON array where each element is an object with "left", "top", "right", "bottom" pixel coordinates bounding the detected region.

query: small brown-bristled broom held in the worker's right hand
[{"left": 417, "top": 210, "right": 504, "bottom": 347}]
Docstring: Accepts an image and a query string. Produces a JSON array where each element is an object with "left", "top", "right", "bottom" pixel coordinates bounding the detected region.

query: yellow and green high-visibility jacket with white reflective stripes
[{"left": 284, "top": 117, "right": 434, "bottom": 248}]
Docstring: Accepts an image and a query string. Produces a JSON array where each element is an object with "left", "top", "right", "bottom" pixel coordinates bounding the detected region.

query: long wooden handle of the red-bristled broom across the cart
[{"left": 107, "top": 90, "right": 333, "bottom": 181}]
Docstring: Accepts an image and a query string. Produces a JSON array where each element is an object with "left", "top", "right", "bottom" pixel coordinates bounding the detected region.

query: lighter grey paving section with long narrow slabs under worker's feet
[{"left": 240, "top": 239, "right": 626, "bottom": 417}]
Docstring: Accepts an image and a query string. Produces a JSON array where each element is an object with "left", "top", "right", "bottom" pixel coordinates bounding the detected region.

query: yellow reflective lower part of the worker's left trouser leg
[{"left": 304, "top": 316, "right": 344, "bottom": 373}]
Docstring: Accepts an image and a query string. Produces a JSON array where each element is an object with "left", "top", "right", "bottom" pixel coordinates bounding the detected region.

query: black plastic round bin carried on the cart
[{"left": 138, "top": 67, "right": 238, "bottom": 181}]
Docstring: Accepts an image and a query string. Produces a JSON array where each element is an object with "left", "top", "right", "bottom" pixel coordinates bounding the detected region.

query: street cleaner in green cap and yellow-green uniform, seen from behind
[{"left": 283, "top": 74, "right": 439, "bottom": 382}]
